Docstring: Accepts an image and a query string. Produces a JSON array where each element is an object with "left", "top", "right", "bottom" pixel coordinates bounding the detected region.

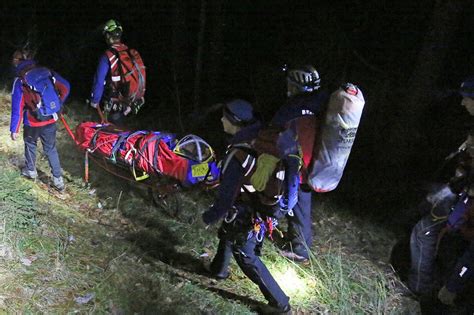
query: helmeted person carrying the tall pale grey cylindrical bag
[{"left": 271, "top": 65, "right": 328, "bottom": 263}]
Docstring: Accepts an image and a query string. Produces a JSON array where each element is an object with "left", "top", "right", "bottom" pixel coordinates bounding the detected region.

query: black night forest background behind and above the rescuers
[{"left": 0, "top": 0, "right": 474, "bottom": 232}]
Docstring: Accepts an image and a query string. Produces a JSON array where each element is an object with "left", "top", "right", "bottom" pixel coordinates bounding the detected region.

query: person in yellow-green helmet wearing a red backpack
[{"left": 90, "top": 20, "right": 145, "bottom": 125}]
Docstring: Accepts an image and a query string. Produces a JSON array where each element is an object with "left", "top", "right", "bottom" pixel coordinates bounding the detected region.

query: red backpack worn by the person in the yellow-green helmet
[{"left": 106, "top": 45, "right": 146, "bottom": 111}]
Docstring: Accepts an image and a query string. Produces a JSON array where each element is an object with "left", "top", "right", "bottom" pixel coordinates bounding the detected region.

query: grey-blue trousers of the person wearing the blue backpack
[{"left": 23, "top": 123, "right": 62, "bottom": 177}]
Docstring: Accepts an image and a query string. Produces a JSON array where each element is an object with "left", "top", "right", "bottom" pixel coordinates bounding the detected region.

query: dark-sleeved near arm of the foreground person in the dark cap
[{"left": 202, "top": 158, "right": 244, "bottom": 224}]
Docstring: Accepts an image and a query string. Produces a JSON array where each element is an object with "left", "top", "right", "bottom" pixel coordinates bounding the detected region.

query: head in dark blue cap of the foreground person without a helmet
[{"left": 221, "top": 99, "right": 256, "bottom": 135}]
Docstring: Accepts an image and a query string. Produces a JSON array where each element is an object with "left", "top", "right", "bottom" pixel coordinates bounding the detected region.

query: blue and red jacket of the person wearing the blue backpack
[{"left": 10, "top": 60, "right": 70, "bottom": 133}]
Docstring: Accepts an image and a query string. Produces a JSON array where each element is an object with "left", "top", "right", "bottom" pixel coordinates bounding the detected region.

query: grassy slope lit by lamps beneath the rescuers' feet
[{"left": 0, "top": 92, "right": 414, "bottom": 314}]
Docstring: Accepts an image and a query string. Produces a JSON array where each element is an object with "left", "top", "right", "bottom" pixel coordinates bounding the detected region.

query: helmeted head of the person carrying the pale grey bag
[{"left": 286, "top": 65, "right": 321, "bottom": 97}]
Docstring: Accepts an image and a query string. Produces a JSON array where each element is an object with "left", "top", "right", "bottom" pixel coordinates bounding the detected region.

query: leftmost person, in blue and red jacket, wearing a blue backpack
[{"left": 10, "top": 48, "right": 70, "bottom": 191}]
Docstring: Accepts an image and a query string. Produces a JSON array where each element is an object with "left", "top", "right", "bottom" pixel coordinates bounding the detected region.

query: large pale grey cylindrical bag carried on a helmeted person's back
[{"left": 308, "top": 83, "right": 365, "bottom": 192}]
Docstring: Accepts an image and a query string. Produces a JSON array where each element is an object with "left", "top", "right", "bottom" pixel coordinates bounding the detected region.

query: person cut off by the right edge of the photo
[{"left": 408, "top": 77, "right": 474, "bottom": 314}]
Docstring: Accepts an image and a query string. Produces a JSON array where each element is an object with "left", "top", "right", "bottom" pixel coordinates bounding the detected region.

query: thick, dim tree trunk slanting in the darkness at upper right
[{"left": 400, "top": 0, "right": 471, "bottom": 175}]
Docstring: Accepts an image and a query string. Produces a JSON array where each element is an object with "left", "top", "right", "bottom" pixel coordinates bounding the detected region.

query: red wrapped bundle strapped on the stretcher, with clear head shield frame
[{"left": 76, "top": 122, "right": 219, "bottom": 186}]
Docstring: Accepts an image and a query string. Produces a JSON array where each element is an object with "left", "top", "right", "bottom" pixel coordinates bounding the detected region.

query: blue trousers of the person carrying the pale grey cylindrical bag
[{"left": 288, "top": 189, "right": 313, "bottom": 258}]
